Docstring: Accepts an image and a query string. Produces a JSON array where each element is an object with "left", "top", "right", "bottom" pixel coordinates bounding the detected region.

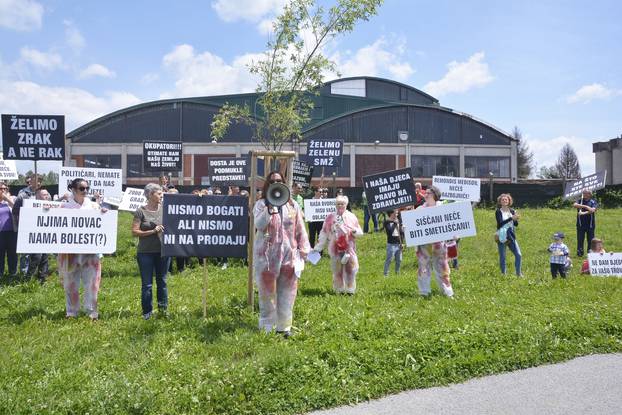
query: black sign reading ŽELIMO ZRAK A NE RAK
[{"left": 2, "top": 114, "right": 65, "bottom": 160}]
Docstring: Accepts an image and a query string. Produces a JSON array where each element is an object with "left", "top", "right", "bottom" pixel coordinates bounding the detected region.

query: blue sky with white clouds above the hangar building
[{"left": 0, "top": 0, "right": 622, "bottom": 174}]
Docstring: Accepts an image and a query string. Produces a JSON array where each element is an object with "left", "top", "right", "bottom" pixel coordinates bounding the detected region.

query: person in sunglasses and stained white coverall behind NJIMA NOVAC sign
[{"left": 58, "top": 178, "right": 106, "bottom": 320}]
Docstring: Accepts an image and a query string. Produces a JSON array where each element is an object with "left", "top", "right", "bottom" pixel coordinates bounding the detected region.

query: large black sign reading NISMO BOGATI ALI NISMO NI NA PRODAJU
[{"left": 162, "top": 194, "right": 248, "bottom": 258}]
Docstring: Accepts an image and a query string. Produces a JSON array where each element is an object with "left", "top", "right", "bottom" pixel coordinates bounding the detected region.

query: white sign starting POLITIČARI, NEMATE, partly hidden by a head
[{"left": 58, "top": 167, "right": 123, "bottom": 197}]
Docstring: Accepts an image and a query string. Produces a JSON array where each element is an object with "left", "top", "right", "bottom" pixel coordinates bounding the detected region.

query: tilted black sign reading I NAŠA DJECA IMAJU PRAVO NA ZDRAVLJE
[{"left": 363, "top": 168, "right": 415, "bottom": 213}]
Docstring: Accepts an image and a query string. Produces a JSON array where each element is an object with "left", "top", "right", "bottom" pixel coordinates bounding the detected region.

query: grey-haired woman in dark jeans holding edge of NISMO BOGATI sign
[{"left": 132, "top": 183, "right": 171, "bottom": 320}]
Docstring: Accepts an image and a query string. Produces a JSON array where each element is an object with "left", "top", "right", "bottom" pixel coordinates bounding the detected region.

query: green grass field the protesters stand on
[{"left": 0, "top": 209, "right": 622, "bottom": 414}]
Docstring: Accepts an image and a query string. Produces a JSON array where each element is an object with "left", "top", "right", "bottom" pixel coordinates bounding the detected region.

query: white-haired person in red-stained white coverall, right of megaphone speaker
[{"left": 313, "top": 196, "right": 363, "bottom": 294}]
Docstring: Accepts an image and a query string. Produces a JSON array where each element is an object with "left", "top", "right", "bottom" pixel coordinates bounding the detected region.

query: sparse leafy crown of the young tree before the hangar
[{"left": 211, "top": 0, "right": 382, "bottom": 151}]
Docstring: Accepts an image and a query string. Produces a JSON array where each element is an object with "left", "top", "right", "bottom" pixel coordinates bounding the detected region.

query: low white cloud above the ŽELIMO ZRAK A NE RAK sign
[{"left": 0, "top": 80, "right": 141, "bottom": 132}]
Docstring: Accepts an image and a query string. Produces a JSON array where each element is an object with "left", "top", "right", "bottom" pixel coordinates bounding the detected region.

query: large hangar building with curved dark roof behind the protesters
[{"left": 66, "top": 77, "right": 518, "bottom": 187}]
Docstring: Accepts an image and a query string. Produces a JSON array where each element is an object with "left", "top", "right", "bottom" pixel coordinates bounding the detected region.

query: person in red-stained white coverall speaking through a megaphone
[{"left": 253, "top": 171, "right": 310, "bottom": 338}]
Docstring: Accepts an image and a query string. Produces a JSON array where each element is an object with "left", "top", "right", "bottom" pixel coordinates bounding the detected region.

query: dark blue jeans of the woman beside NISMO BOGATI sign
[{"left": 136, "top": 252, "right": 171, "bottom": 315}]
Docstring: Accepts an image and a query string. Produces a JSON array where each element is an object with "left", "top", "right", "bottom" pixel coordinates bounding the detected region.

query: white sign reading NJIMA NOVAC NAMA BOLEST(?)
[{"left": 17, "top": 207, "right": 117, "bottom": 254}]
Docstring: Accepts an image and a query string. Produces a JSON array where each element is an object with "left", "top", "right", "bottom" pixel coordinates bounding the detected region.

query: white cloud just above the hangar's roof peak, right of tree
[{"left": 331, "top": 37, "right": 415, "bottom": 80}]
